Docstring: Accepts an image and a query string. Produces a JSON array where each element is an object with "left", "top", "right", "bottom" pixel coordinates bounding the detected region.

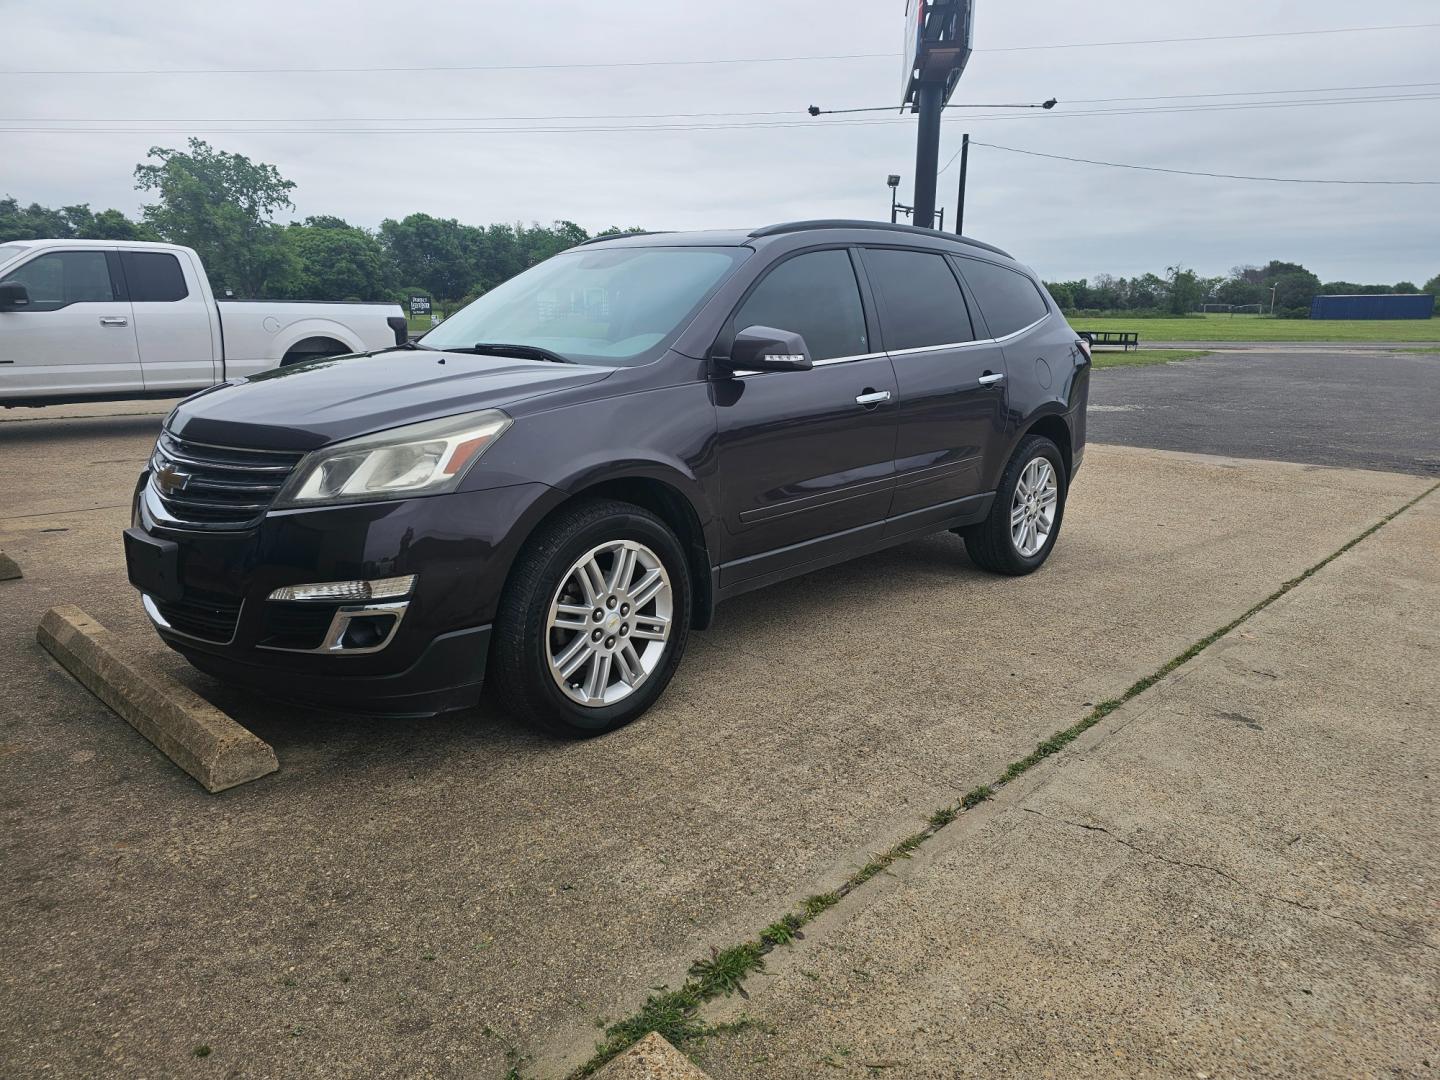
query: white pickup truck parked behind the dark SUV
[{"left": 0, "top": 240, "right": 406, "bottom": 408}]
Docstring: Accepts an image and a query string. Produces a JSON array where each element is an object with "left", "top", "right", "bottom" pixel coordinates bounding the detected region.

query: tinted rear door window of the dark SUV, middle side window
[{"left": 865, "top": 248, "right": 975, "bottom": 348}]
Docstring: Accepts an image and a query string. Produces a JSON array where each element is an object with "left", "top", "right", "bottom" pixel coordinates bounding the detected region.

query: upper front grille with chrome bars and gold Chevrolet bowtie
[{"left": 150, "top": 432, "right": 305, "bottom": 528}]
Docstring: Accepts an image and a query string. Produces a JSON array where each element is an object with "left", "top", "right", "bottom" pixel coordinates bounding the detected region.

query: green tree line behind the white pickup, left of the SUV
[{"left": 0, "top": 138, "right": 639, "bottom": 307}]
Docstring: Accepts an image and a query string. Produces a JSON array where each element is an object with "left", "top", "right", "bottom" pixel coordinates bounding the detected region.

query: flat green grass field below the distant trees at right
[{"left": 1070, "top": 314, "right": 1440, "bottom": 344}]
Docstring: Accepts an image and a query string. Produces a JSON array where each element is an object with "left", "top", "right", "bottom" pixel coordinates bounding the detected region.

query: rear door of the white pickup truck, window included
[{"left": 120, "top": 249, "right": 222, "bottom": 390}]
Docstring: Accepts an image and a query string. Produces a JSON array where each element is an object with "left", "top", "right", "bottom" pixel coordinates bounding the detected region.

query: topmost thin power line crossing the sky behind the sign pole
[{"left": 0, "top": 23, "right": 1440, "bottom": 75}]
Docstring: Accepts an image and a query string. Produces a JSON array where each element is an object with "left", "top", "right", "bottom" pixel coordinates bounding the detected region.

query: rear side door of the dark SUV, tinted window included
[{"left": 864, "top": 248, "right": 1005, "bottom": 533}]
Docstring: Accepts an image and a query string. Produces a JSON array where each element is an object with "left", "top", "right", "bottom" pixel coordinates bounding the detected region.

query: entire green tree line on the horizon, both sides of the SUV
[{"left": 0, "top": 138, "right": 1440, "bottom": 318}]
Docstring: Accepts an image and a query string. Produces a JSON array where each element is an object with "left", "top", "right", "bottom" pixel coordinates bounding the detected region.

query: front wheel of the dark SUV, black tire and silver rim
[{"left": 488, "top": 498, "right": 691, "bottom": 739}]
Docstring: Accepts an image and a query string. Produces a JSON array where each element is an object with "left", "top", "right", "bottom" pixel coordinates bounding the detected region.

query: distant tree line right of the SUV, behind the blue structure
[{"left": 1045, "top": 259, "right": 1440, "bottom": 318}]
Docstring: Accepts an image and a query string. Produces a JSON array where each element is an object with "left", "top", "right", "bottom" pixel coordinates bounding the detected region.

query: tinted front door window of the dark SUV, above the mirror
[{"left": 734, "top": 251, "right": 870, "bottom": 360}]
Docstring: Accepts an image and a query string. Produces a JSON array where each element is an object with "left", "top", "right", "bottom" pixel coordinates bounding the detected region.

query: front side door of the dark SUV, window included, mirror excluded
[{"left": 713, "top": 248, "right": 896, "bottom": 586}]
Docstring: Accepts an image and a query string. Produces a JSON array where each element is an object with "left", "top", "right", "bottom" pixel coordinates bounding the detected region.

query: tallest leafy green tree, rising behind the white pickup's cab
[{"left": 135, "top": 138, "right": 298, "bottom": 297}]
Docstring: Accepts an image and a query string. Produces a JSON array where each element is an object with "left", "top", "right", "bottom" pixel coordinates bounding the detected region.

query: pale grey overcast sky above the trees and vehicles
[{"left": 0, "top": 0, "right": 1440, "bottom": 284}]
